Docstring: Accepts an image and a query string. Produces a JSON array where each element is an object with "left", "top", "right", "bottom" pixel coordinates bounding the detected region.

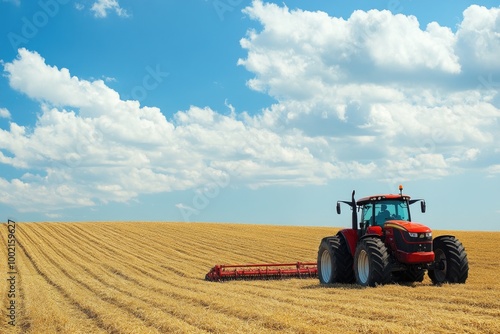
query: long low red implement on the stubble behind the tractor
[{"left": 205, "top": 262, "right": 318, "bottom": 282}]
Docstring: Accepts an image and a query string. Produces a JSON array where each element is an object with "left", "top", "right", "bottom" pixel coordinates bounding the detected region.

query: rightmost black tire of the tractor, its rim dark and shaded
[{"left": 429, "top": 235, "right": 469, "bottom": 284}]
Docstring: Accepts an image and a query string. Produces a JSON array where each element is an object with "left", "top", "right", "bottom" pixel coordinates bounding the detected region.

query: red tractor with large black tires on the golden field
[{"left": 317, "top": 186, "right": 469, "bottom": 286}]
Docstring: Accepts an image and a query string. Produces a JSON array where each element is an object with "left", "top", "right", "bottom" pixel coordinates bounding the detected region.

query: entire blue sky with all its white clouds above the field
[{"left": 0, "top": 0, "right": 500, "bottom": 231}]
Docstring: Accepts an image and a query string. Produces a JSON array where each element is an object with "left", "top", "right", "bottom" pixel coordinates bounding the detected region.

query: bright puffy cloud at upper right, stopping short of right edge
[{"left": 239, "top": 1, "right": 461, "bottom": 99}]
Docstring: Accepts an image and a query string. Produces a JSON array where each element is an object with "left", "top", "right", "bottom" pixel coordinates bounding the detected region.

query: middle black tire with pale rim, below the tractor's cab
[{"left": 354, "top": 238, "right": 392, "bottom": 286}]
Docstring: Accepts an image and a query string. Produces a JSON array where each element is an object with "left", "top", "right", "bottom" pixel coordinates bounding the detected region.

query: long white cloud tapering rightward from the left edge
[{"left": 0, "top": 49, "right": 362, "bottom": 210}]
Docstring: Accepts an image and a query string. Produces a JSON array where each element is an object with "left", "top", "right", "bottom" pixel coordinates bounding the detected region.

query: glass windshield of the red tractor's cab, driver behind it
[{"left": 362, "top": 200, "right": 410, "bottom": 226}]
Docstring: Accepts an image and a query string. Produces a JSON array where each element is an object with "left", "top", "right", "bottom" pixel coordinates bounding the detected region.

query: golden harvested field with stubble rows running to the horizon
[{"left": 0, "top": 223, "right": 500, "bottom": 333}]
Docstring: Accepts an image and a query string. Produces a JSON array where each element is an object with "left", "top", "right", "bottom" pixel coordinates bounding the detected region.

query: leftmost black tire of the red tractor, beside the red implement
[{"left": 318, "top": 235, "right": 354, "bottom": 284}]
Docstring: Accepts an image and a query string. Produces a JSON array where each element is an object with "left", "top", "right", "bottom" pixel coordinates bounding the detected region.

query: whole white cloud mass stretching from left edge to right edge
[{"left": 0, "top": 1, "right": 500, "bottom": 212}]
